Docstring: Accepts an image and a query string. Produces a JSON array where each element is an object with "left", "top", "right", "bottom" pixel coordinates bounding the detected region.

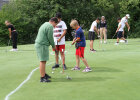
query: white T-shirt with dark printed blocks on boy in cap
[{"left": 53, "top": 21, "right": 67, "bottom": 45}]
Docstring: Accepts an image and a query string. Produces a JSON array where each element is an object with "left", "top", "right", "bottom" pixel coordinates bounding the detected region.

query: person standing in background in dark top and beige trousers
[{"left": 99, "top": 16, "right": 107, "bottom": 43}]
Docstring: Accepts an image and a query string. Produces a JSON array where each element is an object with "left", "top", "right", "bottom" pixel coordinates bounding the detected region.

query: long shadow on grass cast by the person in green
[{"left": 52, "top": 77, "right": 114, "bottom": 82}]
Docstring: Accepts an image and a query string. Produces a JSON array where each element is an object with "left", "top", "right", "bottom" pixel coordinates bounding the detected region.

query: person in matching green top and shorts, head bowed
[{"left": 35, "top": 17, "right": 58, "bottom": 82}]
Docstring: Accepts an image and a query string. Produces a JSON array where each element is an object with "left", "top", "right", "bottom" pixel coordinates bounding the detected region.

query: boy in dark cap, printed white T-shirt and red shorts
[{"left": 52, "top": 13, "right": 67, "bottom": 70}]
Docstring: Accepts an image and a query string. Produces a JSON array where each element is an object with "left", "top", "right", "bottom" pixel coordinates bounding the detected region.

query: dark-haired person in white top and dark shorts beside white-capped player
[{"left": 115, "top": 18, "right": 127, "bottom": 45}]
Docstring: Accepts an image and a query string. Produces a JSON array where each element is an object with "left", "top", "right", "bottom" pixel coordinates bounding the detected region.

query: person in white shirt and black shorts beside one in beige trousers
[{"left": 88, "top": 18, "right": 100, "bottom": 52}]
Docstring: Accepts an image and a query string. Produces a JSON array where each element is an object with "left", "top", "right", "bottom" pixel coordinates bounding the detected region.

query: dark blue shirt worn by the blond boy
[{"left": 75, "top": 27, "right": 86, "bottom": 47}]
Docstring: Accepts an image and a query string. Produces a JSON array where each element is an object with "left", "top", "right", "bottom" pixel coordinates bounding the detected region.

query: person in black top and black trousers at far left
[{"left": 5, "top": 21, "right": 18, "bottom": 51}]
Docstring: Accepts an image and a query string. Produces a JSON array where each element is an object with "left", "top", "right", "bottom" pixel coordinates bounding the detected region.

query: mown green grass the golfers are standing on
[{"left": 0, "top": 39, "right": 140, "bottom": 100}]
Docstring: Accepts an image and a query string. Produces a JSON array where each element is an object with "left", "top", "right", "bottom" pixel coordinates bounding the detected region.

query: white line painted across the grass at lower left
[{"left": 5, "top": 62, "right": 54, "bottom": 100}]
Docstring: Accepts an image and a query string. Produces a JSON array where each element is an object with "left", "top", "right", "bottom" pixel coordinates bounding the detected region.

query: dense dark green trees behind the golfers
[{"left": 0, "top": 0, "right": 140, "bottom": 45}]
